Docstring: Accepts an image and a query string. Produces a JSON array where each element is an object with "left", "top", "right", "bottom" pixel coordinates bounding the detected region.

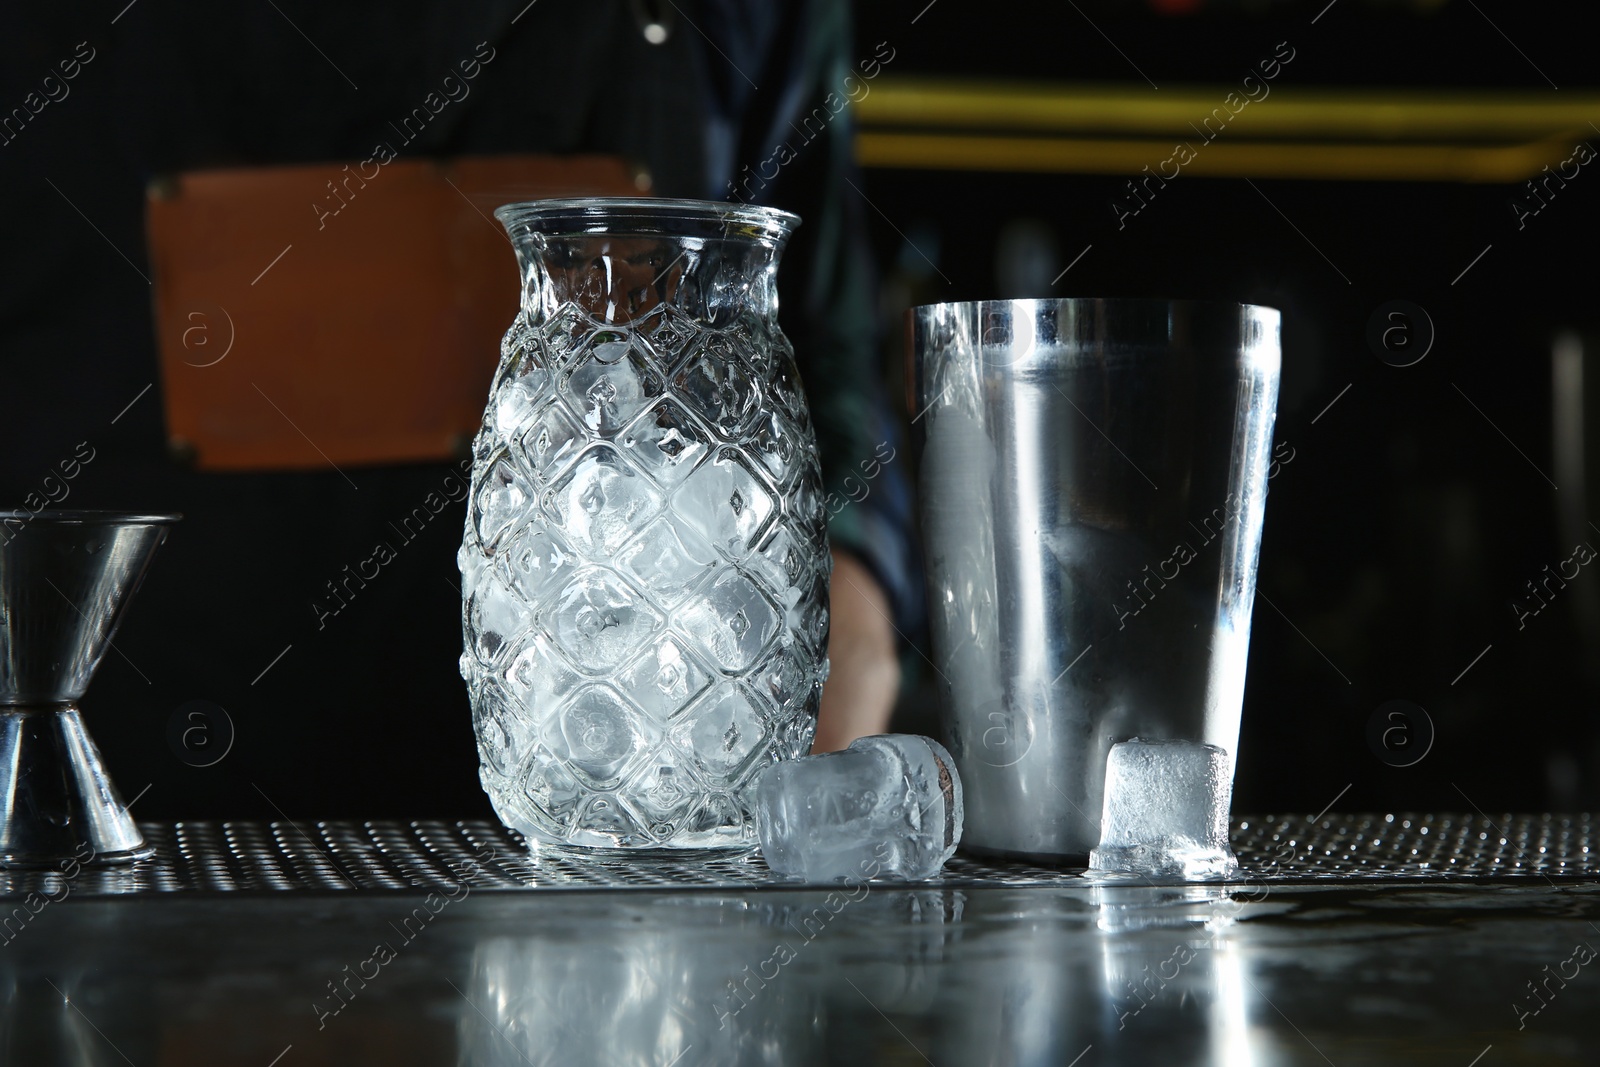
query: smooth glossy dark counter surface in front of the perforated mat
[{"left": 0, "top": 880, "right": 1600, "bottom": 1067}]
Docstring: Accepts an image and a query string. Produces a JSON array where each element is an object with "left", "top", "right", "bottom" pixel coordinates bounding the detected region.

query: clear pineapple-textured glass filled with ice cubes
[{"left": 459, "top": 198, "right": 832, "bottom": 851}]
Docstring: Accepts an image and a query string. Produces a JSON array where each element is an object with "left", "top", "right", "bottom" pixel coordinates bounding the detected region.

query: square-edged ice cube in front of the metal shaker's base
[{"left": 1090, "top": 737, "right": 1238, "bottom": 881}]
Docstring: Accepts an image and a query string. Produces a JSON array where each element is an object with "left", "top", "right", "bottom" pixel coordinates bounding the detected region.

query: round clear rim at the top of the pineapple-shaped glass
[{"left": 494, "top": 197, "right": 800, "bottom": 240}]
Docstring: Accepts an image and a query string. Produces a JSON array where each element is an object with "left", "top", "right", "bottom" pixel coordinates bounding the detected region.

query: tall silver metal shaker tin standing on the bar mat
[{"left": 909, "top": 299, "right": 1280, "bottom": 862}]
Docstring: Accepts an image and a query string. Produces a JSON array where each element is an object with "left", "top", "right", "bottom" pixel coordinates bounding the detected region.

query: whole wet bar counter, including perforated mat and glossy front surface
[{"left": 0, "top": 813, "right": 1600, "bottom": 1067}]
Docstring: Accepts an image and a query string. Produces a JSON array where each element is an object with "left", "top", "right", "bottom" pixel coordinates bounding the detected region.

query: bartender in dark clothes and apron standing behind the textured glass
[{"left": 0, "top": 0, "right": 920, "bottom": 817}]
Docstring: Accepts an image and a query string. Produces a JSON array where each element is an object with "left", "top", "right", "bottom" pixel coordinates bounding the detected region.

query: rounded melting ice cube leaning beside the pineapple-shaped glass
[{"left": 755, "top": 734, "right": 962, "bottom": 881}]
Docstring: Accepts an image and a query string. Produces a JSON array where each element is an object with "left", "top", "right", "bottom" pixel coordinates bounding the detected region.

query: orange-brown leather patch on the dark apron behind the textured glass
[{"left": 147, "top": 157, "right": 643, "bottom": 470}]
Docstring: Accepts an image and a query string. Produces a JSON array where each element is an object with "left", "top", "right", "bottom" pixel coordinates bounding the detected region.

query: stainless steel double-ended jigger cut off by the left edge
[{"left": 0, "top": 510, "right": 181, "bottom": 867}]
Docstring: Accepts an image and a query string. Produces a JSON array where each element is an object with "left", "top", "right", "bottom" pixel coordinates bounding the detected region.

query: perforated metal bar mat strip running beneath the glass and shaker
[{"left": 0, "top": 813, "right": 1600, "bottom": 899}]
